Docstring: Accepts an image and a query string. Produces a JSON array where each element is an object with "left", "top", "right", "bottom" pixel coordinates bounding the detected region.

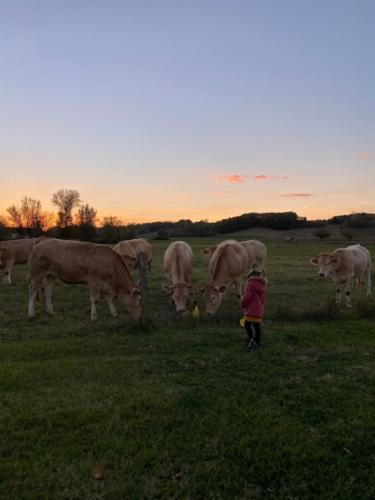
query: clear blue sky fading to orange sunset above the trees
[{"left": 0, "top": 0, "right": 375, "bottom": 222}]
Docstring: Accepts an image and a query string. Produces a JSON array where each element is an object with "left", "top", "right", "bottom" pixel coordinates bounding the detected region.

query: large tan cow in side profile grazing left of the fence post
[{"left": 29, "top": 238, "right": 141, "bottom": 320}]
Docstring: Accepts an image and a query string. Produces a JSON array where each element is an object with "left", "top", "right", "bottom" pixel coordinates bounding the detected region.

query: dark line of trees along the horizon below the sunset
[{"left": 0, "top": 189, "right": 375, "bottom": 243}]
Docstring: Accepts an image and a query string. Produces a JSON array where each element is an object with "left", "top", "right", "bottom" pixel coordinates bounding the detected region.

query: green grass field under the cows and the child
[{"left": 0, "top": 239, "right": 375, "bottom": 499}]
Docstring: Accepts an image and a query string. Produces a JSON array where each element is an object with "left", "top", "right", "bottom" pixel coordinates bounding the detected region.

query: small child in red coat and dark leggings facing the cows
[{"left": 241, "top": 270, "right": 267, "bottom": 349}]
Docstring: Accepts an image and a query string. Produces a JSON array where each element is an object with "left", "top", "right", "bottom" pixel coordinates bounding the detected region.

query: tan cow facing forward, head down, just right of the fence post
[{"left": 163, "top": 241, "right": 194, "bottom": 312}]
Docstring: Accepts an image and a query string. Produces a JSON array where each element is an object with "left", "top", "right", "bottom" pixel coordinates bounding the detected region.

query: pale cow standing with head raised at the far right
[{"left": 310, "top": 244, "right": 371, "bottom": 307}]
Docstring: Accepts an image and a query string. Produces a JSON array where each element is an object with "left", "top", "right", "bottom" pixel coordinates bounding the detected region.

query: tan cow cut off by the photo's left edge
[{"left": 0, "top": 236, "right": 44, "bottom": 285}]
